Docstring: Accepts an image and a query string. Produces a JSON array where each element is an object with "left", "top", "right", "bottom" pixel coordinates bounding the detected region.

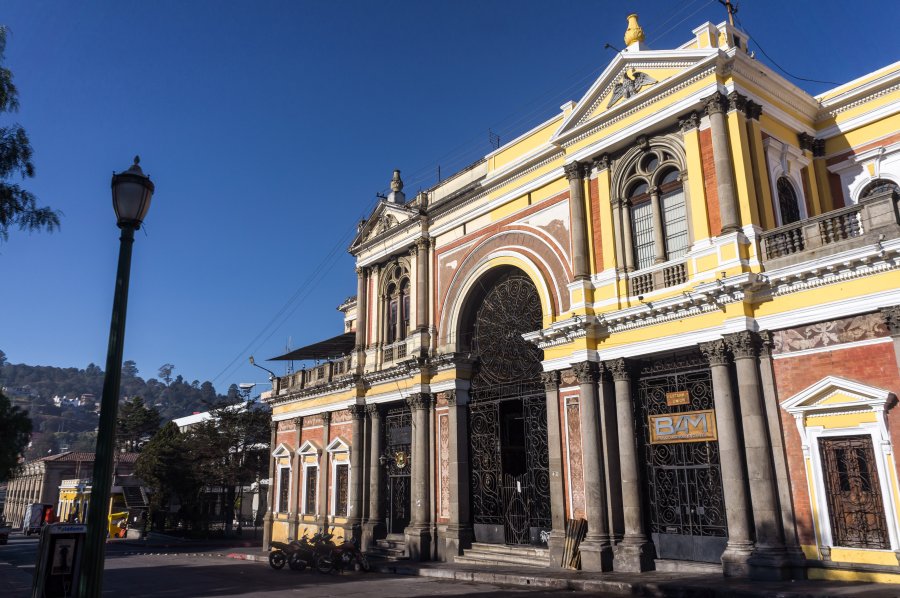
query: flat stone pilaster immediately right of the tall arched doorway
[{"left": 541, "top": 372, "right": 566, "bottom": 567}]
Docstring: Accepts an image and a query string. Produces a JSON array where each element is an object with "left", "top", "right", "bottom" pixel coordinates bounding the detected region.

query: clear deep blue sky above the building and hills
[{"left": 0, "top": 0, "right": 900, "bottom": 400}]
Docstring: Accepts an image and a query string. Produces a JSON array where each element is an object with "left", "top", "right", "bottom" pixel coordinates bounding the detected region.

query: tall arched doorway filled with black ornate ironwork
[{"left": 460, "top": 267, "right": 551, "bottom": 544}]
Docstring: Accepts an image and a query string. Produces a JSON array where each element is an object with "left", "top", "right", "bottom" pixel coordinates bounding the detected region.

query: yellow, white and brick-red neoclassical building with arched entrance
[{"left": 266, "top": 16, "right": 900, "bottom": 581}]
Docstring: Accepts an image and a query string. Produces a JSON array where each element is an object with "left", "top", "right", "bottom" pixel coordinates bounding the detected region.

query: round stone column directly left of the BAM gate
[{"left": 606, "top": 359, "right": 656, "bottom": 572}]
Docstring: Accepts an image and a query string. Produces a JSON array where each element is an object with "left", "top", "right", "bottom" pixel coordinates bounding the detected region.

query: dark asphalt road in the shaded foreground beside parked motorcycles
[{"left": 0, "top": 534, "right": 572, "bottom": 598}]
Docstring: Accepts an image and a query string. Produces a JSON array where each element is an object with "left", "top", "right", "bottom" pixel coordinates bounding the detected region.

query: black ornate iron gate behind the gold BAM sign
[{"left": 637, "top": 355, "right": 728, "bottom": 562}]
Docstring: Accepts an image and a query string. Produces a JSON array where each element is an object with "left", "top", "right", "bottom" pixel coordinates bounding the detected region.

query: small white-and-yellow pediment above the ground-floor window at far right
[{"left": 781, "top": 376, "right": 894, "bottom": 415}]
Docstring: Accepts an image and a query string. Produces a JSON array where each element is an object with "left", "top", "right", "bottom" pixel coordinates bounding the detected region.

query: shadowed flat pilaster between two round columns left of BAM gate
[{"left": 598, "top": 363, "right": 625, "bottom": 544}]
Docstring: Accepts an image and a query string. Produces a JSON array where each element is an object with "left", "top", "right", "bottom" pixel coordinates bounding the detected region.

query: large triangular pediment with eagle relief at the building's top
[{"left": 554, "top": 48, "right": 718, "bottom": 139}]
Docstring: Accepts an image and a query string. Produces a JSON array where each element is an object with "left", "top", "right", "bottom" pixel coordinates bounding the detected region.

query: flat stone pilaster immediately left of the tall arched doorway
[{"left": 445, "top": 389, "right": 475, "bottom": 556}]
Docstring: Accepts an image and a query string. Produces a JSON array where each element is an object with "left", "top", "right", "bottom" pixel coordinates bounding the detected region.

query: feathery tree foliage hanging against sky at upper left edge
[{"left": 0, "top": 27, "right": 60, "bottom": 241}]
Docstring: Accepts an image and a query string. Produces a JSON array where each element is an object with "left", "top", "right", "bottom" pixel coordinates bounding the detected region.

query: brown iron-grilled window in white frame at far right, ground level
[{"left": 819, "top": 436, "right": 891, "bottom": 550}]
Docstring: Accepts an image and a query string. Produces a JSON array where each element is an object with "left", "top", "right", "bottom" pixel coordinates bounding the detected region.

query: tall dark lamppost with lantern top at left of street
[{"left": 78, "top": 156, "right": 153, "bottom": 598}]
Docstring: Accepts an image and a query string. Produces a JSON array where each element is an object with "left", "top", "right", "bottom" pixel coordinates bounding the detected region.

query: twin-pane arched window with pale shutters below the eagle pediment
[{"left": 617, "top": 144, "right": 690, "bottom": 270}]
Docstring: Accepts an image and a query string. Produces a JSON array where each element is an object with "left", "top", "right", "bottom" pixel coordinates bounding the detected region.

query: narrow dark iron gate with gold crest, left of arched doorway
[{"left": 383, "top": 404, "right": 412, "bottom": 534}]
